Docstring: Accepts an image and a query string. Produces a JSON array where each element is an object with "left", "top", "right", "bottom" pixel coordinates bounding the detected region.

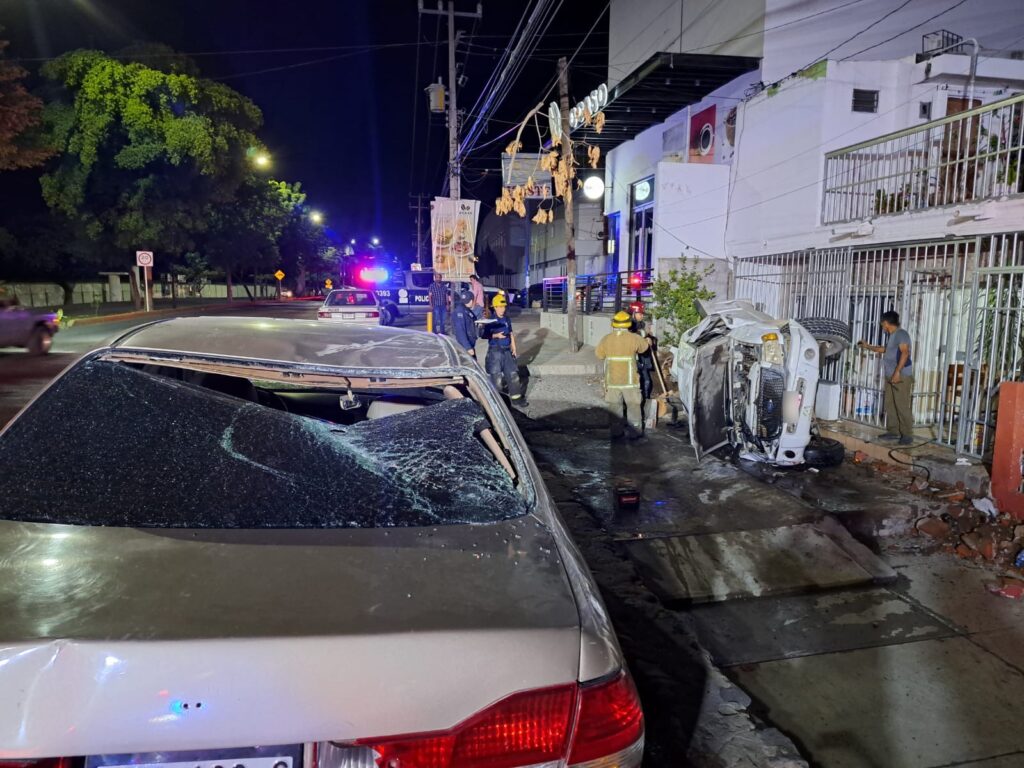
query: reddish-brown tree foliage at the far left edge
[{"left": 0, "top": 34, "right": 53, "bottom": 171}]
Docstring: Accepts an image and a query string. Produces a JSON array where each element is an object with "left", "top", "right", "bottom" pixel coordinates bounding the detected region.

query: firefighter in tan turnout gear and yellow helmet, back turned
[{"left": 595, "top": 311, "right": 650, "bottom": 437}]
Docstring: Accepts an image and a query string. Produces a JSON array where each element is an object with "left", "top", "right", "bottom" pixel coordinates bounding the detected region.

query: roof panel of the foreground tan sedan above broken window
[{"left": 112, "top": 316, "right": 459, "bottom": 370}]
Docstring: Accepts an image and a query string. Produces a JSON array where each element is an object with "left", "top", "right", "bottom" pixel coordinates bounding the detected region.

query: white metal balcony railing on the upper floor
[{"left": 822, "top": 95, "right": 1024, "bottom": 224}]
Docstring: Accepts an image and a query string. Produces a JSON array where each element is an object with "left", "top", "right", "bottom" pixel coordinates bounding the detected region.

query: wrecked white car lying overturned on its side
[{"left": 673, "top": 300, "right": 850, "bottom": 466}]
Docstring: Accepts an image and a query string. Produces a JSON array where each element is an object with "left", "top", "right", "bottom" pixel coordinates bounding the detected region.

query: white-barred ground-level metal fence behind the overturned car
[{"left": 735, "top": 232, "right": 1024, "bottom": 456}]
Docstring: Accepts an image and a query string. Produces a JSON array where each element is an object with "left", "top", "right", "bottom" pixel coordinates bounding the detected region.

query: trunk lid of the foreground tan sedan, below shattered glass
[{"left": 0, "top": 516, "right": 581, "bottom": 757}]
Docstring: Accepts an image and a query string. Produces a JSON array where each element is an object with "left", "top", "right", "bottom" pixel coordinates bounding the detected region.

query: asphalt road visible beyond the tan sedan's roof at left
[{"left": 0, "top": 301, "right": 426, "bottom": 426}]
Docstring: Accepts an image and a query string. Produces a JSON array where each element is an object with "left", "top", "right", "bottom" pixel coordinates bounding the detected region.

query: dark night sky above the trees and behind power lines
[{"left": 0, "top": 0, "right": 607, "bottom": 260}]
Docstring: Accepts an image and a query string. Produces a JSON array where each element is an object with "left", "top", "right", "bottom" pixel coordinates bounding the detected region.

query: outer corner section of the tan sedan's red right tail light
[{"left": 569, "top": 672, "right": 643, "bottom": 767}]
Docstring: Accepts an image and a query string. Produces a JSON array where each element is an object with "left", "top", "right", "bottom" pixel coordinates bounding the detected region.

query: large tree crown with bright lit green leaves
[{"left": 41, "top": 49, "right": 262, "bottom": 259}]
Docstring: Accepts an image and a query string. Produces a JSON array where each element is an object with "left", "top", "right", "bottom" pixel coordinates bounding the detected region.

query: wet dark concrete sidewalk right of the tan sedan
[{"left": 523, "top": 368, "right": 1024, "bottom": 768}]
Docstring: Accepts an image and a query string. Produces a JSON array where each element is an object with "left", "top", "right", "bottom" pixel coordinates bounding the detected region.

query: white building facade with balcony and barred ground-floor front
[{"left": 582, "top": 0, "right": 1024, "bottom": 455}]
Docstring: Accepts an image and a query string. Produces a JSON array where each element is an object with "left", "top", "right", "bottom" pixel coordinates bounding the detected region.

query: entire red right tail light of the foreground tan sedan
[{"left": 331, "top": 672, "right": 643, "bottom": 768}]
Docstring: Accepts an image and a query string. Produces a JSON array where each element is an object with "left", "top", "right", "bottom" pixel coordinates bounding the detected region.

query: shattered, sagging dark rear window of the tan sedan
[{"left": 0, "top": 359, "right": 526, "bottom": 528}]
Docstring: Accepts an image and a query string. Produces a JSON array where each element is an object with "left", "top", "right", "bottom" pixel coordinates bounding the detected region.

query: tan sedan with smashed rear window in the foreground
[{"left": 0, "top": 316, "right": 643, "bottom": 768}]
